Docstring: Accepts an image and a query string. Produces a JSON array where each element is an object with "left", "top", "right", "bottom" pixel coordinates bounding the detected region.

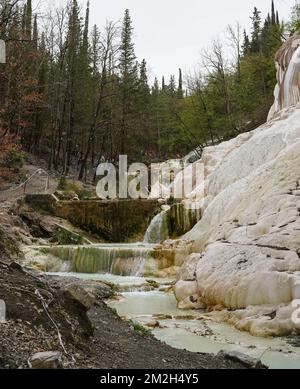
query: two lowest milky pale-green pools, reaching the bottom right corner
[{"left": 108, "top": 292, "right": 300, "bottom": 369}]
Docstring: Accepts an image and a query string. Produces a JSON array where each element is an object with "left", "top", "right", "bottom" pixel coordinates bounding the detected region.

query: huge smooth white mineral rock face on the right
[{"left": 176, "top": 37, "right": 300, "bottom": 336}]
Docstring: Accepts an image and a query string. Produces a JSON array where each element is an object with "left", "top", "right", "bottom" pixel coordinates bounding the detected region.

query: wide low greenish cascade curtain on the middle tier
[{"left": 35, "top": 244, "right": 157, "bottom": 277}]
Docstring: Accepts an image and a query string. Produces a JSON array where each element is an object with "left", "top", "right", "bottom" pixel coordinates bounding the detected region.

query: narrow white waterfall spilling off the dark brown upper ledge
[{"left": 144, "top": 210, "right": 169, "bottom": 244}]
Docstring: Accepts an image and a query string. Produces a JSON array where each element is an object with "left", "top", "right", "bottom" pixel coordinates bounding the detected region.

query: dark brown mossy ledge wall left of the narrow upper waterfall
[{"left": 25, "top": 194, "right": 160, "bottom": 243}]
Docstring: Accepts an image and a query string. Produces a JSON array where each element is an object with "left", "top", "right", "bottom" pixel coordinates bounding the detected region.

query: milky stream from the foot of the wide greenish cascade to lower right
[{"left": 49, "top": 273, "right": 300, "bottom": 369}]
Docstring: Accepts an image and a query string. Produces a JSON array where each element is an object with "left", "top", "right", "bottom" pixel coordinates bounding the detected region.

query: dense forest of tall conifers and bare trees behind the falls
[{"left": 0, "top": 0, "right": 300, "bottom": 181}]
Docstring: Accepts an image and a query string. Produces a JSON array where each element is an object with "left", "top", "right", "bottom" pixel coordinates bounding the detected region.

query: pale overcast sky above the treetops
[{"left": 36, "top": 0, "right": 295, "bottom": 79}]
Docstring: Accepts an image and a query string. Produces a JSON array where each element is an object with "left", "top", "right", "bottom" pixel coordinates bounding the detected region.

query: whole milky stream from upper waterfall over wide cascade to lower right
[{"left": 27, "top": 208, "right": 300, "bottom": 369}]
